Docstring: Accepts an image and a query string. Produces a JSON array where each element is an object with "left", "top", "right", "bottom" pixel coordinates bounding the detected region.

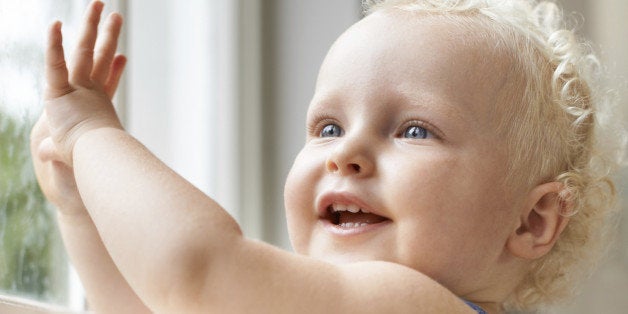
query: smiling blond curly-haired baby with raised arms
[{"left": 32, "top": 0, "right": 621, "bottom": 313}]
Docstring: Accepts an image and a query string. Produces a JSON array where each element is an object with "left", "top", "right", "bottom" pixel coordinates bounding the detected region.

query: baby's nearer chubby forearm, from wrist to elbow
[{"left": 73, "top": 128, "right": 242, "bottom": 309}]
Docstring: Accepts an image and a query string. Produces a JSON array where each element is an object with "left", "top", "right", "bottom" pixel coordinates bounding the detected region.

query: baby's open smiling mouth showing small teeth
[{"left": 323, "top": 203, "right": 390, "bottom": 229}]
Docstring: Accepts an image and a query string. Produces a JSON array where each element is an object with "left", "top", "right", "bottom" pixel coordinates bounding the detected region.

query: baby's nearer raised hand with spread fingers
[{"left": 42, "top": 1, "right": 124, "bottom": 167}]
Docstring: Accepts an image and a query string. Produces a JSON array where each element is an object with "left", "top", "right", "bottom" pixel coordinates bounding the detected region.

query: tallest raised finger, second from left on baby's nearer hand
[{"left": 70, "top": 0, "right": 104, "bottom": 85}]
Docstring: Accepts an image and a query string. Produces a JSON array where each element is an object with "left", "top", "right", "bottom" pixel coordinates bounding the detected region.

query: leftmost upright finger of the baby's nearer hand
[{"left": 45, "top": 21, "right": 72, "bottom": 99}]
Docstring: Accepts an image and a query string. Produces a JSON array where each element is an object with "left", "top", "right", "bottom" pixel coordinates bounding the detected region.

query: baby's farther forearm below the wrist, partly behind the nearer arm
[{"left": 57, "top": 212, "right": 150, "bottom": 314}]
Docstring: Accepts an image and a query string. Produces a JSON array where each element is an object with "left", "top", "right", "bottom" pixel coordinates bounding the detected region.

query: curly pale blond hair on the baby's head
[{"left": 363, "top": 0, "right": 626, "bottom": 310}]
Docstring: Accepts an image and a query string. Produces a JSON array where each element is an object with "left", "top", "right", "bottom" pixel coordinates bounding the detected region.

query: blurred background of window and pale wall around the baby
[{"left": 0, "top": 0, "right": 628, "bottom": 314}]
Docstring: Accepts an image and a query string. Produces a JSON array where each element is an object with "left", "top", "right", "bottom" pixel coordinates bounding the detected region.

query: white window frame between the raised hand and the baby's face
[{"left": 126, "top": 0, "right": 262, "bottom": 239}]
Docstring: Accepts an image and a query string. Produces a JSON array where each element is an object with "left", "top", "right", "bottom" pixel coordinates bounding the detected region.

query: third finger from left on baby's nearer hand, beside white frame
[{"left": 92, "top": 13, "right": 122, "bottom": 85}]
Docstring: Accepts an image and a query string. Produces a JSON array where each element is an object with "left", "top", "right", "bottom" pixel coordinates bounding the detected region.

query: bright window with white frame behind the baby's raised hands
[{"left": 0, "top": 0, "right": 261, "bottom": 313}]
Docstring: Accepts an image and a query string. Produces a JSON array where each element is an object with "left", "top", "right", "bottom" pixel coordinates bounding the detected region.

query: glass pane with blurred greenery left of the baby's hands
[{"left": 0, "top": 0, "right": 91, "bottom": 305}]
